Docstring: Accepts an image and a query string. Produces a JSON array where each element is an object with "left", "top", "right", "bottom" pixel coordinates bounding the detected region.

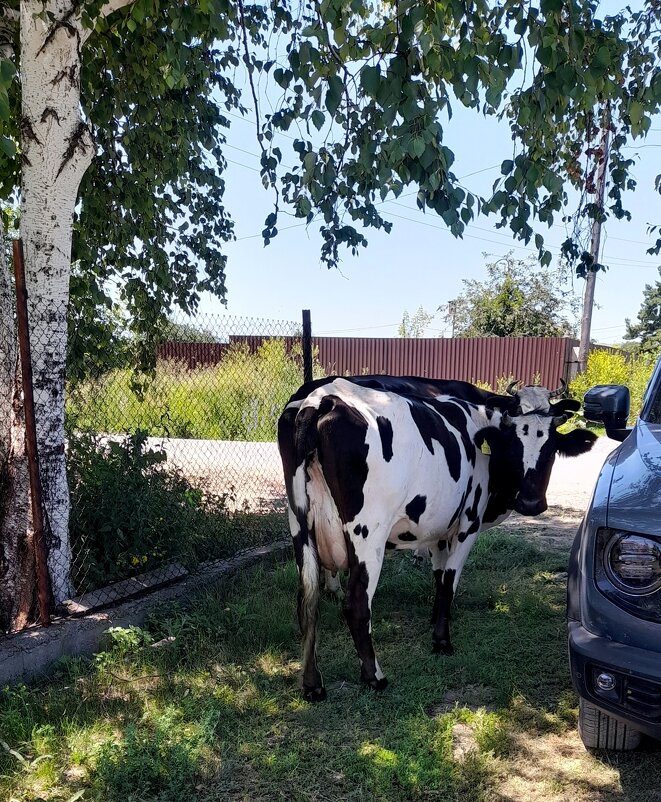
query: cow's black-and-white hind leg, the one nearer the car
[{"left": 344, "top": 533, "right": 388, "bottom": 691}]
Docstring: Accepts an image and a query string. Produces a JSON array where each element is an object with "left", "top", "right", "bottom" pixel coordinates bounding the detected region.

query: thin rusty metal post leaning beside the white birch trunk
[{"left": 13, "top": 240, "right": 51, "bottom": 626}]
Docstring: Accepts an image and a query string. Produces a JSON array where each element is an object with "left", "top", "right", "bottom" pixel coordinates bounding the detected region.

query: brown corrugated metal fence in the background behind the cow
[{"left": 158, "top": 336, "right": 578, "bottom": 389}]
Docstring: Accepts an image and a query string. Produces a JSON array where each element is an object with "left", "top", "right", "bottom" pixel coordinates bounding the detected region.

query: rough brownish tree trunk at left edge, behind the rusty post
[{"left": 0, "top": 219, "right": 36, "bottom": 632}]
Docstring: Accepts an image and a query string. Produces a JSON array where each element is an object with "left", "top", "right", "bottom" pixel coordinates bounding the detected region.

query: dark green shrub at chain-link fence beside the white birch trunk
[{"left": 67, "top": 431, "right": 231, "bottom": 592}]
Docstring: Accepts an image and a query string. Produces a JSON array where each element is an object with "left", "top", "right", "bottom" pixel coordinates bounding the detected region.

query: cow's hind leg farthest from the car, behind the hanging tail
[{"left": 289, "top": 510, "right": 326, "bottom": 702}]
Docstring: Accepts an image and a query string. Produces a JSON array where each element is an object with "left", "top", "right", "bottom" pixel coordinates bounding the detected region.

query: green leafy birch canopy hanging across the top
[{"left": 0, "top": 0, "right": 661, "bottom": 342}]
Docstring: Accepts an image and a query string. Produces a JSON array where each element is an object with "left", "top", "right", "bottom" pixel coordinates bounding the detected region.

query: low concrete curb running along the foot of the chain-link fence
[{"left": 0, "top": 541, "right": 291, "bottom": 687}]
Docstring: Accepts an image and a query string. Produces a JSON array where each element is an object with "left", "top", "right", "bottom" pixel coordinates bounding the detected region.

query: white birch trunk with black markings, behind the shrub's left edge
[{"left": 20, "top": 0, "right": 99, "bottom": 602}]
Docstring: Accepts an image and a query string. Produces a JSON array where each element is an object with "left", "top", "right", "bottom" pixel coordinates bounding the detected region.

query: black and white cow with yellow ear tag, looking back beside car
[{"left": 278, "top": 377, "right": 595, "bottom": 701}]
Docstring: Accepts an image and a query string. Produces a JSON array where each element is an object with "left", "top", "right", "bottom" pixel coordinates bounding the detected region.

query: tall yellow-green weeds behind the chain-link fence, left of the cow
[{"left": 67, "top": 338, "right": 322, "bottom": 441}]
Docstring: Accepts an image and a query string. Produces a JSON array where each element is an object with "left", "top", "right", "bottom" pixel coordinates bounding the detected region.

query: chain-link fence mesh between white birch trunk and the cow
[{"left": 60, "top": 315, "right": 303, "bottom": 610}]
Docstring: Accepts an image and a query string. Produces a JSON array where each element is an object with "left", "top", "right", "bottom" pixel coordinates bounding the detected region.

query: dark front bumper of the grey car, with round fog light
[{"left": 569, "top": 621, "right": 661, "bottom": 740}]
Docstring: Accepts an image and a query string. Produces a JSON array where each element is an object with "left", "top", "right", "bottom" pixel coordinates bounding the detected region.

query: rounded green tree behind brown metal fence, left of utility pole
[{"left": 446, "top": 251, "right": 579, "bottom": 337}]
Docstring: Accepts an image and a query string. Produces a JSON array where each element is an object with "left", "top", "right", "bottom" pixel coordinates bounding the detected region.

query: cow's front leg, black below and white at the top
[{"left": 430, "top": 532, "right": 477, "bottom": 654}]
